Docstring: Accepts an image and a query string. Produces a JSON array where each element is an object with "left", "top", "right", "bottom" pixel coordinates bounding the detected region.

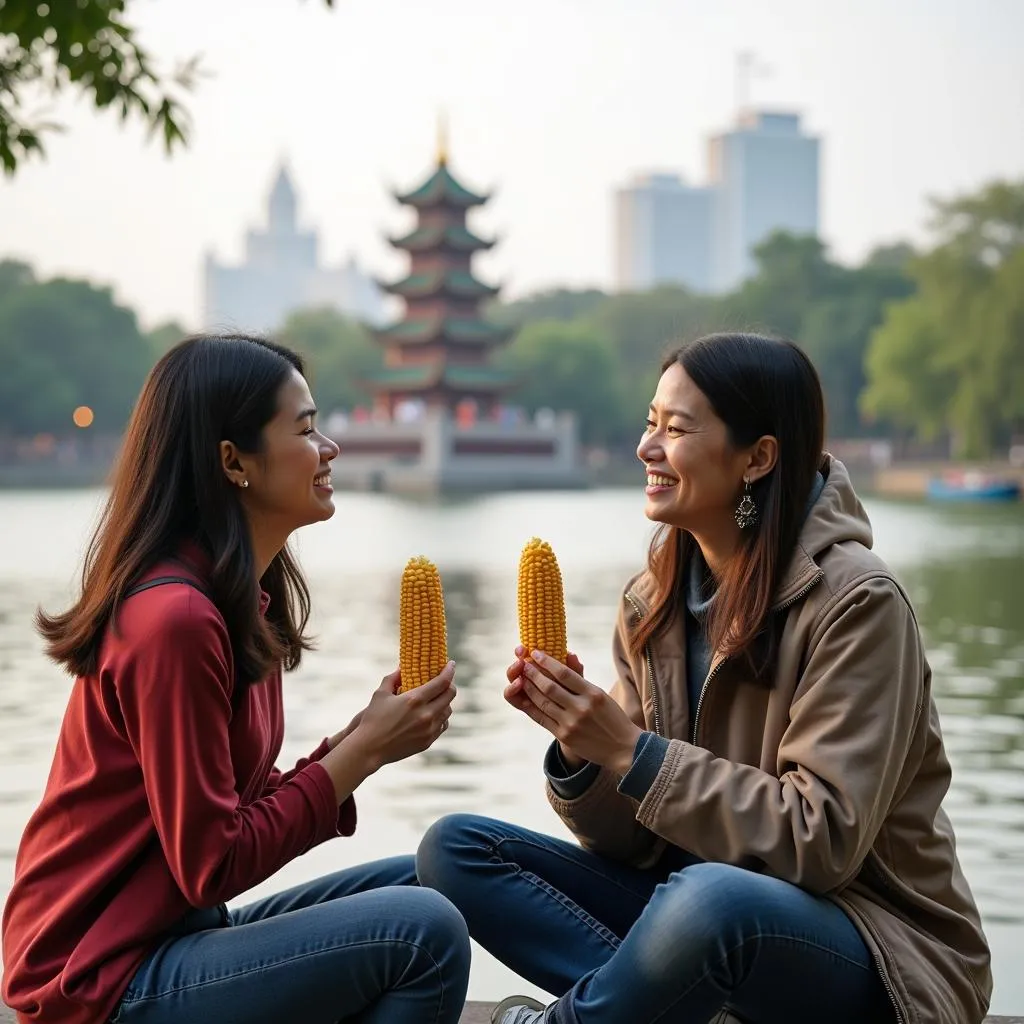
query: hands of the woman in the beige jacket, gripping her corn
[{"left": 506, "top": 651, "right": 643, "bottom": 775}]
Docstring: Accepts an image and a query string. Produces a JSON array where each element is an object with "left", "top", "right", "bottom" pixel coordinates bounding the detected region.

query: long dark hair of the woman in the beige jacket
[{"left": 630, "top": 334, "right": 825, "bottom": 675}]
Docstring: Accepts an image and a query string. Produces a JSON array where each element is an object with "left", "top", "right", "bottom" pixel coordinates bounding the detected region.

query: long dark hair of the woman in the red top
[{"left": 36, "top": 335, "right": 309, "bottom": 694}]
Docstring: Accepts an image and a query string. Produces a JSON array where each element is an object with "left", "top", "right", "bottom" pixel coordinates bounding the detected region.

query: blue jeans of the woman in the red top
[{"left": 112, "top": 857, "right": 469, "bottom": 1024}]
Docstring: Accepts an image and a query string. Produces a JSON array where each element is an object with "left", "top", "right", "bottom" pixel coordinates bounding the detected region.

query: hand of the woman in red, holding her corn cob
[{"left": 348, "top": 662, "right": 456, "bottom": 771}]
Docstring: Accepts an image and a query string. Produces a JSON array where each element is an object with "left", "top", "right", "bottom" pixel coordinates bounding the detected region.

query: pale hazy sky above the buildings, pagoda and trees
[{"left": 0, "top": 0, "right": 1024, "bottom": 327}]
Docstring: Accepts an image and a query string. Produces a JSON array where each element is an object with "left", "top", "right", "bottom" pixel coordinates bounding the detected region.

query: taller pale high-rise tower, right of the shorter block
[{"left": 709, "top": 112, "right": 820, "bottom": 292}]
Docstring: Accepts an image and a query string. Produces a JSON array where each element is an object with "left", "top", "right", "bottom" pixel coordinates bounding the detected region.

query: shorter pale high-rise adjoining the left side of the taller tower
[{"left": 615, "top": 174, "right": 713, "bottom": 292}]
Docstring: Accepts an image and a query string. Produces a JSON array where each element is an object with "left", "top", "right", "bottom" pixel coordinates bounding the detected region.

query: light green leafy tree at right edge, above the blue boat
[{"left": 862, "top": 180, "right": 1024, "bottom": 457}]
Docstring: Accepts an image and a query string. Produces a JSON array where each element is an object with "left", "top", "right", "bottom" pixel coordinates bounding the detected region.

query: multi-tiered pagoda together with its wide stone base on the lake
[{"left": 328, "top": 136, "right": 587, "bottom": 494}]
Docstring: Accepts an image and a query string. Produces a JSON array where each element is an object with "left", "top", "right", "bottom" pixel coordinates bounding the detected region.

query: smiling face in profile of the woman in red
[{"left": 228, "top": 371, "right": 338, "bottom": 539}]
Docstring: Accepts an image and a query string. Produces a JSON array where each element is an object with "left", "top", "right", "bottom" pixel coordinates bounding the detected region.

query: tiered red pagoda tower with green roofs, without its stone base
[{"left": 369, "top": 132, "right": 514, "bottom": 419}]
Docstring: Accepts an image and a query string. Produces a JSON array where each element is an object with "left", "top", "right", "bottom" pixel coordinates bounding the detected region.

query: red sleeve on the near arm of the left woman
[{"left": 116, "top": 589, "right": 339, "bottom": 906}]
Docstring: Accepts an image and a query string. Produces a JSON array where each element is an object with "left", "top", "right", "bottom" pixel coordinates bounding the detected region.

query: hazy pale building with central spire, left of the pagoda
[{"left": 203, "top": 167, "right": 386, "bottom": 333}]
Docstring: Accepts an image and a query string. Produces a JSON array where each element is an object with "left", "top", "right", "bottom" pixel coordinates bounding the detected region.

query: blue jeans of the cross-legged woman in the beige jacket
[{"left": 416, "top": 814, "right": 896, "bottom": 1024}]
